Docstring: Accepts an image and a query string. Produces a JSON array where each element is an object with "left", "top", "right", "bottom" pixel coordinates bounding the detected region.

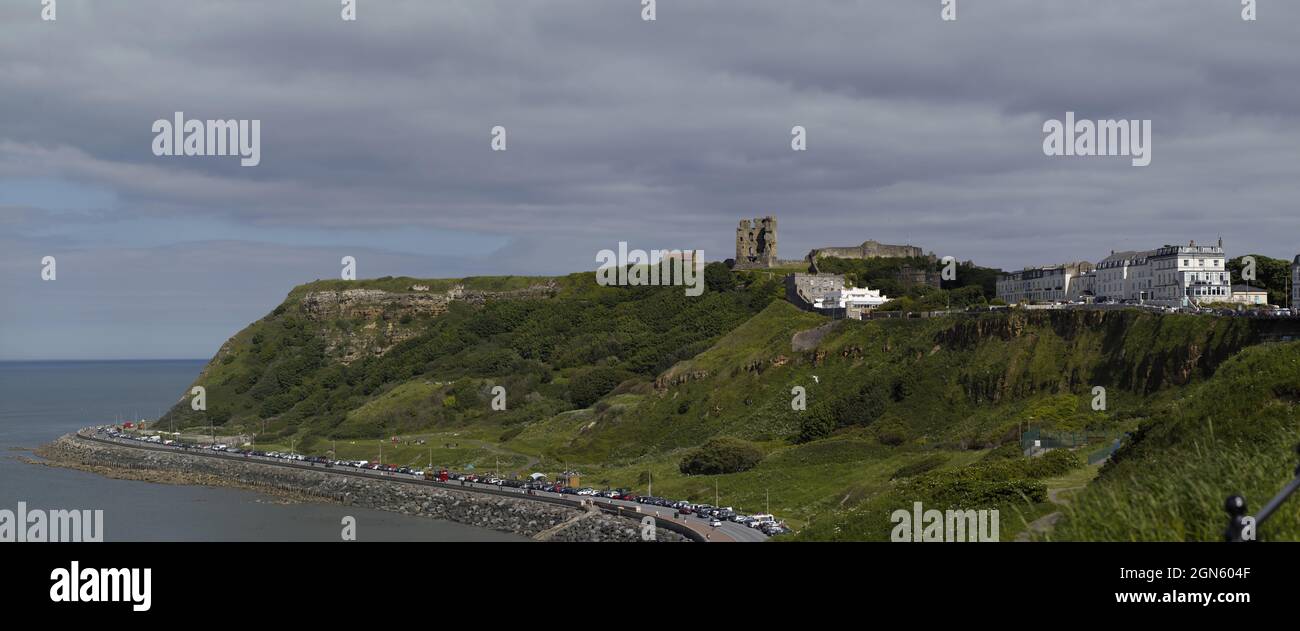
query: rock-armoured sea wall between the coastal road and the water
[{"left": 36, "top": 435, "right": 685, "bottom": 541}]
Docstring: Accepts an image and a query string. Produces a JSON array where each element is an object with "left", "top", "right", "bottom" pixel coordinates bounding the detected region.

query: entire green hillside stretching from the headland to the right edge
[{"left": 164, "top": 260, "right": 1300, "bottom": 540}]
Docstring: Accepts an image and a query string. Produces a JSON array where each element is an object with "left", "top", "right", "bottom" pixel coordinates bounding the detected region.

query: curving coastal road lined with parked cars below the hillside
[{"left": 77, "top": 431, "right": 767, "bottom": 543}]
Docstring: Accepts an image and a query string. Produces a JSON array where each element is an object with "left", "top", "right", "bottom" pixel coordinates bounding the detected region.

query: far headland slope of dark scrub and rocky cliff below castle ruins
[{"left": 157, "top": 264, "right": 781, "bottom": 445}]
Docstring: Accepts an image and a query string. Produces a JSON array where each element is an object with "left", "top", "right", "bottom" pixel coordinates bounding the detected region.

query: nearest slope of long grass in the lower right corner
[{"left": 1052, "top": 342, "right": 1300, "bottom": 541}]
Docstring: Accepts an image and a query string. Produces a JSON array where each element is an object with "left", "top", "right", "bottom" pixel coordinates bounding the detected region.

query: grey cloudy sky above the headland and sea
[{"left": 0, "top": 0, "right": 1300, "bottom": 359}]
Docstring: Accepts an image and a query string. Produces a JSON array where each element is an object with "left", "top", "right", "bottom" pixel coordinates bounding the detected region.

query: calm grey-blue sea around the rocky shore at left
[{"left": 0, "top": 360, "right": 525, "bottom": 541}]
